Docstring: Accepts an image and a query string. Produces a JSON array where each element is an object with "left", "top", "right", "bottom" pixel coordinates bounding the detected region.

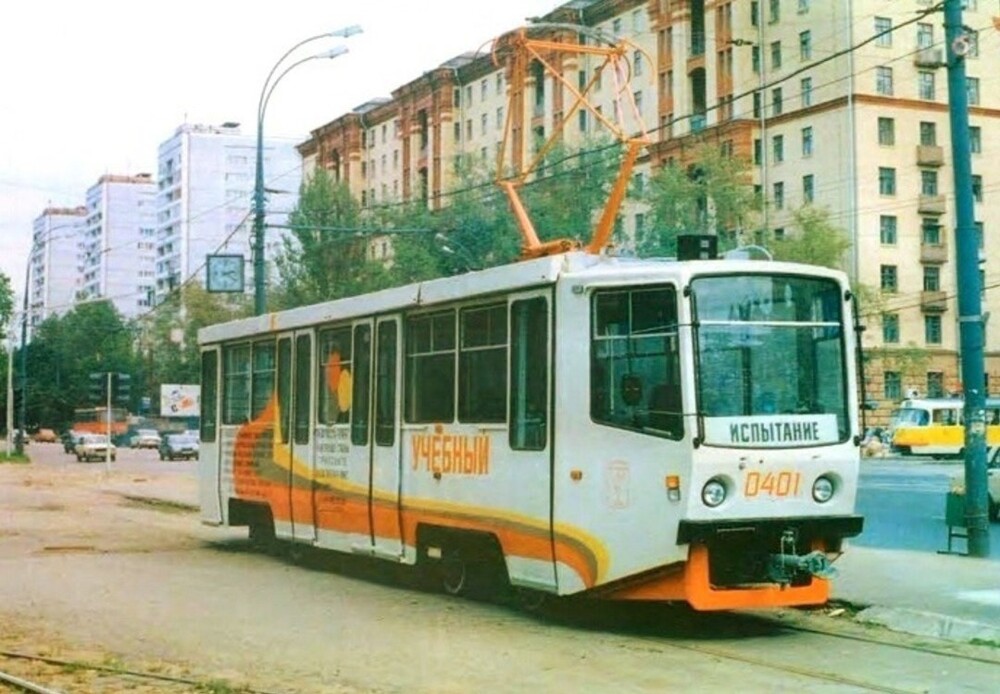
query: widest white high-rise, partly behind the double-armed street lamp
[{"left": 154, "top": 123, "right": 303, "bottom": 303}]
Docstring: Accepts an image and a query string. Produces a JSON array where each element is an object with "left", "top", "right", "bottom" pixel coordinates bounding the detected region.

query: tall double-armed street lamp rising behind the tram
[{"left": 253, "top": 24, "right": 361, "bottom": 316}]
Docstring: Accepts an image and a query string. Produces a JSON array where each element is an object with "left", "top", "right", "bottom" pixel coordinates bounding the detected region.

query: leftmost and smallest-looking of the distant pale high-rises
[{"left": 27, "top": 205, "right": 87, "bottom": 333}]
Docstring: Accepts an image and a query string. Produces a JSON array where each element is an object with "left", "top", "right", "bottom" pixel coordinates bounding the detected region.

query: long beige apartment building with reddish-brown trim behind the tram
[{"left": 299, "top": 0, "right": 1000, "bottom": 417}]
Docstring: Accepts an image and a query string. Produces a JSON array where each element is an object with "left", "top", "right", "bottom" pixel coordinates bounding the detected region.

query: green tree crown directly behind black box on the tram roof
[{"left": 636, "top": 143, "right": 760, "bottom": 257}]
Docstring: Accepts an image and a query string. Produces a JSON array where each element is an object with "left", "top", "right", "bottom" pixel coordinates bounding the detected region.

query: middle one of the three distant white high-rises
[{"left": 76, "top": 174, "right": 156, "bottom": 319}]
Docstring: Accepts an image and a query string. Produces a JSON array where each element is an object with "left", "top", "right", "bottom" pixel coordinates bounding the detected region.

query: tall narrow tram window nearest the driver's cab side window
[{"left": 509, "top": 297, "right": 549, "bottom": 451}]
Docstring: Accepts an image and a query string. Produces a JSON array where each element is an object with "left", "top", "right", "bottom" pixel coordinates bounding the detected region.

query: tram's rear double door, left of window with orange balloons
[{"left": 274, "top": 332, "right": 316, "bottom": 541}]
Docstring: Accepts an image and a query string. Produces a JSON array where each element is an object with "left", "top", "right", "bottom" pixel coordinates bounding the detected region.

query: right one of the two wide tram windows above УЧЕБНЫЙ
[{"left": 458, "top": 304, "right": 507, "bottom": 422}]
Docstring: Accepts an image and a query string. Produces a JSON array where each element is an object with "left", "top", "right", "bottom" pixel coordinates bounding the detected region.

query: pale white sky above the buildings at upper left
[{"left": 0, "top": 0, "right": 563, "bottom": 305}]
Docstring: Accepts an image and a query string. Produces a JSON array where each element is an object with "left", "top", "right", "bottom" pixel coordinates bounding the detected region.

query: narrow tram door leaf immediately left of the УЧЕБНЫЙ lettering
[{"left": 368, "top": 316, "right": 403, "bottom": 557}]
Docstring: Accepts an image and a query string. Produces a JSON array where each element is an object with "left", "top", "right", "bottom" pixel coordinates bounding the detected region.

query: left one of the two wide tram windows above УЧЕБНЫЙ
[{"left": 405, "top": 311, "right": 455, "bottom": 424}]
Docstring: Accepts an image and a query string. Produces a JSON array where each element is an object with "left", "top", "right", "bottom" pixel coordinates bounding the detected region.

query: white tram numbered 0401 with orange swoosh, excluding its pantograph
[{"left": 199, "top": 252, "right": 862, "bottom": 610}]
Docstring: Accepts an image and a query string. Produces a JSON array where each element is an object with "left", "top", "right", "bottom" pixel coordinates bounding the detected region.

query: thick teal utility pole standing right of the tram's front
[{"left": 944, "top": 0, "right": 990, "bottom": 557}]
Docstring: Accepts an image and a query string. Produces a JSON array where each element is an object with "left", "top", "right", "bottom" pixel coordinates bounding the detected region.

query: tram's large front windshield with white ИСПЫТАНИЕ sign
[{"left": 691, "top": 275, "right": 849, "bottom": 447}]
